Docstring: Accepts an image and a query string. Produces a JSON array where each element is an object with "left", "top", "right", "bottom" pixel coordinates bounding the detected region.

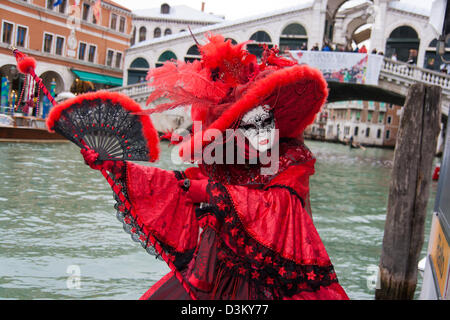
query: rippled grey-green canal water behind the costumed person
[{"left": 0, "top": 141, "right": 437, "bottom": 300}]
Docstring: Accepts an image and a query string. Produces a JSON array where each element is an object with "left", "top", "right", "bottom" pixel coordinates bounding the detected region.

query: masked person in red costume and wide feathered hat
[{"left": 82, "top": 35, "right": 348, "bottom": 300}]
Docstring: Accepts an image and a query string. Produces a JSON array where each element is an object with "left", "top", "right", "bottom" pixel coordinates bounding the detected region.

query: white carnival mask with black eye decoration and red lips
[{"left": 239, "top": 105, "right": 275, "bottom": 152}]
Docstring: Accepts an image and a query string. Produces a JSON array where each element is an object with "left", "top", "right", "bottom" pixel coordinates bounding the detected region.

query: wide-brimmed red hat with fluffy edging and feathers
[{"left": 147, "top": 35, "right": 328, "bottom": 161}]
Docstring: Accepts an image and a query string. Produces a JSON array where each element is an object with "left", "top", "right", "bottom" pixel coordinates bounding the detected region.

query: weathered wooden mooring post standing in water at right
[{"left": 375, "top": 83, "right": 442, "bottom": 300}]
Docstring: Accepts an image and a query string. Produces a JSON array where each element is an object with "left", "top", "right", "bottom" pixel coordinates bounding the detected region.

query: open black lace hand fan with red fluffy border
[{"left": 47, "top": 91, "right": 159, "bottom": 162}]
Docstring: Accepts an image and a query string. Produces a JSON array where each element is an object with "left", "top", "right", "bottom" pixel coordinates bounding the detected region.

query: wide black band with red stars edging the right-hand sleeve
[{"left": 207, "top": 183, "right": 338, "bottom": 299}]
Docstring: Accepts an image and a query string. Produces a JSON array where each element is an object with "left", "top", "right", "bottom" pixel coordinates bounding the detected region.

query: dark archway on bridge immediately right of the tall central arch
[{"left": 385, "top": 26, "right": 420, "bottom": 64}]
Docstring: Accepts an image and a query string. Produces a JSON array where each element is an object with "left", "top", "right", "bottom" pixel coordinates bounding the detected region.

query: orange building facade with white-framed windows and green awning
[{"left": 0, "top": 0, "right": 132, "bottom": 114}]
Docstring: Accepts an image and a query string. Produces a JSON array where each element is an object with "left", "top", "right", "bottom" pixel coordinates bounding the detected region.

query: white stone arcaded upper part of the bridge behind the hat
[{"left": 123, "top": 0, "right": 440, "bottom": 84}]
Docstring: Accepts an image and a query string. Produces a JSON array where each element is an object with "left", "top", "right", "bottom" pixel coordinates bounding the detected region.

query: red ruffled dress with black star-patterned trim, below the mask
[{"left": 110, "top": 139, "right": 348, "bottom": 300}]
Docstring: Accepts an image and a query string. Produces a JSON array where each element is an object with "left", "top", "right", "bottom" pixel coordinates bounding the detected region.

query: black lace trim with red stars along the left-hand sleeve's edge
[{"left": 111, "top": 162, "right": 195, "bottom": 270}]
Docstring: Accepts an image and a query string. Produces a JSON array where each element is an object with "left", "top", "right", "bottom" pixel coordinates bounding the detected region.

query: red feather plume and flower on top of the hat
[{"left": 143, "top": 35, "right": 258, "bottom": 125}]
